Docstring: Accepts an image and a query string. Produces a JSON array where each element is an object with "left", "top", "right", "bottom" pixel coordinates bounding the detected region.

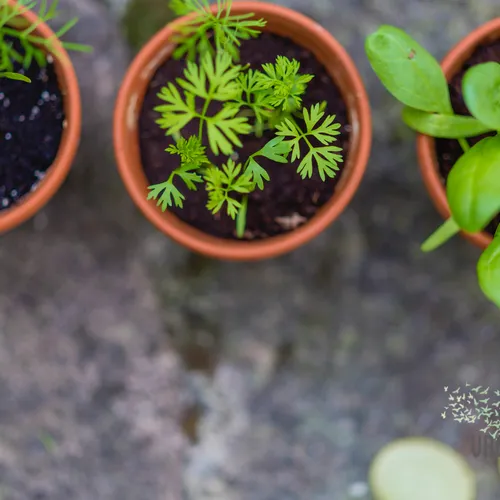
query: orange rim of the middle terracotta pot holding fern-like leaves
[{"left": 114, "top": 1, "right": 371, "bottom": 260}]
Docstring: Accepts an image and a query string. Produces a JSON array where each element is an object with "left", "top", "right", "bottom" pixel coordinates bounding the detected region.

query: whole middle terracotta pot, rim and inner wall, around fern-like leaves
[{"left": 114, "top": 1, "right": 372, "bottom": 260}]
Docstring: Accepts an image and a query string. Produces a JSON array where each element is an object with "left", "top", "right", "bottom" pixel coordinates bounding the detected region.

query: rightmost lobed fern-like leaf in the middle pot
[{"left": 276, "top": 104, "right": 343, "bottom": 181}]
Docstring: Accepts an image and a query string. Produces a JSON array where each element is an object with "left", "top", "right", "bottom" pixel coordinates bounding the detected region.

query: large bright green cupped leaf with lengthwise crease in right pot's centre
[{"left": 446, "top": 135, "right": 500, "bottom": 233}]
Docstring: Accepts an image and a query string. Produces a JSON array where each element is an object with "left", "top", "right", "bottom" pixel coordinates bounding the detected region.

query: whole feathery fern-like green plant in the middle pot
[{"left": 148, "top": 0, "right": 342, "bottom": 238}]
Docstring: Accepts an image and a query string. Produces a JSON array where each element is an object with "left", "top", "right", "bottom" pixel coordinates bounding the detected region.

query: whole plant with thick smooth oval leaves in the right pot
[{"left": 365, "top": 26, "right": 500, "bottom": 307}]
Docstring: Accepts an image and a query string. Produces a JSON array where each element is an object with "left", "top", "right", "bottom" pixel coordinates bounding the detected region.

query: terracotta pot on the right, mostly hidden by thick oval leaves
[{"left": 417, "top": 17, "right": 500, "bottom": 248}]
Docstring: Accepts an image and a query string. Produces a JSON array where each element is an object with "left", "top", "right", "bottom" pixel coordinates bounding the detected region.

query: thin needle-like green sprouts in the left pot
[{"left": 0, "top": 0, "right": 91, "bottom": 83}]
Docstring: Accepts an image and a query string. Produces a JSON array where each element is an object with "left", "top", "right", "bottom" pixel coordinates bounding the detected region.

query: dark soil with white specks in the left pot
[{"left": 0, "top": 40, "right": 64, "bottom": 210}]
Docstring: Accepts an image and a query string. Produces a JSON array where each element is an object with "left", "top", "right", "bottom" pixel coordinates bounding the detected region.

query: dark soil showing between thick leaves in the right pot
[{"left": 436, "top": 41, "right": 500, "bottom": 235}]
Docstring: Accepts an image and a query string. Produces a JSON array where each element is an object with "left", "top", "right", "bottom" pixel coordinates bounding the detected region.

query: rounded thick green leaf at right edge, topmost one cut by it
[{"left": 462, "top": 62, "right": 500, "bottom": 130}]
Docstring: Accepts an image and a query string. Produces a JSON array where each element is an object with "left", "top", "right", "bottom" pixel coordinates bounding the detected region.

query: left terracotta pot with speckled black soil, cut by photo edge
[{"left": 0, "top": 0, "right": 81, "bottom": 233}]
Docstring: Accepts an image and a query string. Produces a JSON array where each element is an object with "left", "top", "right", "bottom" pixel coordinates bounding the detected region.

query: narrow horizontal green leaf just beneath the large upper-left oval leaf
[{"left": 403, "top": 106, "right": 492, "bottom": 139}]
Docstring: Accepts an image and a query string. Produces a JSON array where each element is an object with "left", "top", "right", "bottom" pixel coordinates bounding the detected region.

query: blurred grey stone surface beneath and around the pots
[{"left": 0, "top": 0, "right": 500, "bottom": 500}]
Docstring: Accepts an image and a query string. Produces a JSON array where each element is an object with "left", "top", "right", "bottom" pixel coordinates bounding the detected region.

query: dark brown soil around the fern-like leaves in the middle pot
[{"left": 139, "top": 33, "right": 350, "bottom": 239}]
